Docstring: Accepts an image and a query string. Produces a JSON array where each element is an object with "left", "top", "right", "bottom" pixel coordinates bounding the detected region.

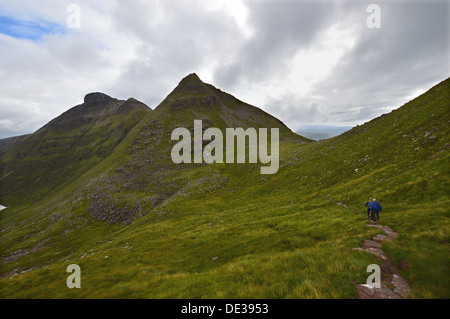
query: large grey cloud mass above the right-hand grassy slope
[{"left": 262, "top": 1, "right": 450, "bottom": 129}]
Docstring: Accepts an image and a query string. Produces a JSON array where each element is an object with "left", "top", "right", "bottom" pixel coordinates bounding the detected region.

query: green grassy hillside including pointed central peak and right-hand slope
[{"left": 0, "top": 76, "right": 450, "bottom": 298}]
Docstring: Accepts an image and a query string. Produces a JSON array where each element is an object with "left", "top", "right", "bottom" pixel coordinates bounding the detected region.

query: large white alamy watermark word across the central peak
[{"left": 170, "top": 120, "right": 279, "bottom": 174}]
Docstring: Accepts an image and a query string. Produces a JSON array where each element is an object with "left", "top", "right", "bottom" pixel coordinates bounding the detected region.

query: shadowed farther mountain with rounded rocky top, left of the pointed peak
[{"left": 0, "top": 93, "right": 151, "bottom": 205}]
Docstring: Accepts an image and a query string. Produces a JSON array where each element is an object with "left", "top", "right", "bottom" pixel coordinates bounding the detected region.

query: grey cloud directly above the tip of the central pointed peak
[{"left": 107, "top": 1, "right": 242, "bottom": 107}]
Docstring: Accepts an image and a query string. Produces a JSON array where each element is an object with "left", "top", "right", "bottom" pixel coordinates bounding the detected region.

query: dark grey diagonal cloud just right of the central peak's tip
[{"left": 214, "top": 1, "right": 328, "bottom": 89}]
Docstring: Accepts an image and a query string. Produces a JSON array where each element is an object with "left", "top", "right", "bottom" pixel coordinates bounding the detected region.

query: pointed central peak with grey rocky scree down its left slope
[{"left": 84, "top": 74, "right": 308, "bottom": 223}]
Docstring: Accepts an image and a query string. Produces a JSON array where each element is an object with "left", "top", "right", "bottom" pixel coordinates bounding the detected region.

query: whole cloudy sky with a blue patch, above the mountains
[{"left": 0, "top": 0, "right": 450, "bottom": 138}]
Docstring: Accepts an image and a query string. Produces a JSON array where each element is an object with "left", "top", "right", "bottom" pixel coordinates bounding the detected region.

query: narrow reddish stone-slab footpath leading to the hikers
[{"left": 328, "top": 197, "right": 411, "bottom": 299}]
